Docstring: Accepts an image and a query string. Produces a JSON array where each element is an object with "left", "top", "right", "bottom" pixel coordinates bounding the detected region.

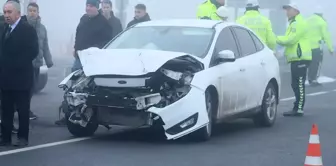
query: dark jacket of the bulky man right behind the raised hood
[{"left": 74, "top": 13, "right": 112, "bottom": 52}]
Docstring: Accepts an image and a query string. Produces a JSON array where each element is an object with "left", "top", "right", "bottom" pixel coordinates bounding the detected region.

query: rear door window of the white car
[{"left": 233, "top": 27, "right": 257, "bottom": 56}]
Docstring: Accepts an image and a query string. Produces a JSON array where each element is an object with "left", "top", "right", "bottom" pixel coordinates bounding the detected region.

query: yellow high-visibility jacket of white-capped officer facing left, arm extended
[{"left": 277, "top": 14, "right": 312, "bottom": 63}]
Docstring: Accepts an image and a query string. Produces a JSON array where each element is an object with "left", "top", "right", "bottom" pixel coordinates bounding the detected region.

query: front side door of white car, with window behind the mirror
[{"left": 209, "top": 27, "right": 246, "bottom": 118}]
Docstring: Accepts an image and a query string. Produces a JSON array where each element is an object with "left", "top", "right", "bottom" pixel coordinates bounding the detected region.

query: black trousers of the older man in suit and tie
[{"left": 1, "top": 90, "right": 31, "bottom": 141}]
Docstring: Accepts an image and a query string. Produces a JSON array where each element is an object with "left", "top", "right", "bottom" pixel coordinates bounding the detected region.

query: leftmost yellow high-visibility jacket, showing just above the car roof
[{"left": 197, "top": 0, "right": 222, "bottom": 20}]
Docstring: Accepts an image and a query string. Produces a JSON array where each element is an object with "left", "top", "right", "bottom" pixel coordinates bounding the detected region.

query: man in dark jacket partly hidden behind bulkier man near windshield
[{"left": 101, "top": 0, "right": 123, "bottom": 38}]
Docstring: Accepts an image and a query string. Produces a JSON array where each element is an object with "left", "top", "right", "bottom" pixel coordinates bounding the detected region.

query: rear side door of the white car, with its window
[{"left": 232, "top": 27, "right": 266, "bottom": 110}]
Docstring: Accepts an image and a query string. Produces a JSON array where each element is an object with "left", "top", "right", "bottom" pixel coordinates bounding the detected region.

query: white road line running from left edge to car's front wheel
[{"left": 0, "top": 137, "right": 93, "bottom": 156}]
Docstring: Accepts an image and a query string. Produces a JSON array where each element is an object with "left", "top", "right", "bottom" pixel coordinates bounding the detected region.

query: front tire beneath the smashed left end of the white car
[{"left": 65, "top": 113, "right": 99, "bottom": 137}]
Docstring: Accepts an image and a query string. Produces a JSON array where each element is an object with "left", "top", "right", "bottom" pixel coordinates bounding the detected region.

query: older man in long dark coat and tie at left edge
[{"left": 0, "top": 1, "right": 39, "bottom": 146}]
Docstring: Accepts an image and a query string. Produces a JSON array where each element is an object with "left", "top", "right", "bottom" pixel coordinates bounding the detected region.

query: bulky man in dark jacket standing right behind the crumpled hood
[{"left": 55, "top": 0, "right": 112, "bottom": 125}]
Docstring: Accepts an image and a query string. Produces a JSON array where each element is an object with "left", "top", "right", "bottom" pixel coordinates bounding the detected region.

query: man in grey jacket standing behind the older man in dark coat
[{"left": 27, "top": 3, "right": 53, "bottom": 120}]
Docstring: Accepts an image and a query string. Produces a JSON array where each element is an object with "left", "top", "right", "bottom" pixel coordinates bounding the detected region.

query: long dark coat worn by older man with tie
[{"left": 0, "top": 18, "right": 39, "bottom": 90}]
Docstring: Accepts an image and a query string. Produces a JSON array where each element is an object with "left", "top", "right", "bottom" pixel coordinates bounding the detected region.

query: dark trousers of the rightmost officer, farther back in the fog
[{"left": 308, "top": 48, "right": 323, "bottom": 81}]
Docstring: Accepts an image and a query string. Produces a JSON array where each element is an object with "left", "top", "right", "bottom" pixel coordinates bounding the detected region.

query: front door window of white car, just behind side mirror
[{"left": 215, "top": 28, "right": 240, "bottom": 57}]
